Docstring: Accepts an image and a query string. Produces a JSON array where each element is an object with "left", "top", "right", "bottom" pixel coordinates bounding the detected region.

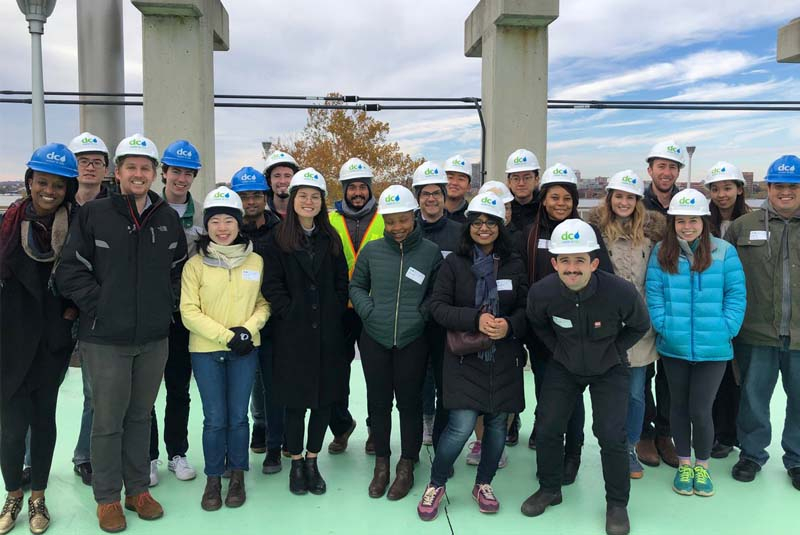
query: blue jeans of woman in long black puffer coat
[{"left": 431, "top": 409, "right": 508, "bottom": 487}]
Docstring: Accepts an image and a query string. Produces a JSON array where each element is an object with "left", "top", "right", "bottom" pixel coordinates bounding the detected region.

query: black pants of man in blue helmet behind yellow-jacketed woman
[{"left": 150, "top": 314, "right": 192, "bottom": 461}]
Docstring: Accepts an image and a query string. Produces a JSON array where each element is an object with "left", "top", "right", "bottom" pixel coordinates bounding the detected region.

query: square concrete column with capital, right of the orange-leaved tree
[{"left": 464, "top": 0, "right": 559, "bottom": 180}]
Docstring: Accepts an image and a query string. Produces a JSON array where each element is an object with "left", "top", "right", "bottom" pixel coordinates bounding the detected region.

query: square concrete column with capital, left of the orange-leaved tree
[{"left": 131, "top": 0, "right": 228, "bottom": 201}]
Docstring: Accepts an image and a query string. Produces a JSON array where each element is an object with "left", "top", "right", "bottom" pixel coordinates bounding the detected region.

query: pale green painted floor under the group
[{"left": 23, "top": 361, "right": 800, "bottom": 535}]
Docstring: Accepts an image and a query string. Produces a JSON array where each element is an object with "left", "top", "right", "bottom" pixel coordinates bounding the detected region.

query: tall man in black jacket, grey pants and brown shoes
[{"left": 56, "top": 134, "right": 186, "bottom": 532}]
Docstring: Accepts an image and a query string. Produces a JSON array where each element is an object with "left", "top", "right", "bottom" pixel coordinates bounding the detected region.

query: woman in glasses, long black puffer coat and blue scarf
[{"left": 417, "top": 192, "right": 528, "bottom": 520}]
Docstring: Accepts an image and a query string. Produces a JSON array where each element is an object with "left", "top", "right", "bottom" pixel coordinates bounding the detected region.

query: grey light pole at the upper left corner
[{"left": 17, "top": 0, "right": 56, "bottom": 149}]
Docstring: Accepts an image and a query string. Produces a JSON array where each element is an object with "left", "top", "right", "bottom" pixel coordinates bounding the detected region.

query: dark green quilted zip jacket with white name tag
[{"left": 350, "top": 225, "right": 442, "bottom": 349}]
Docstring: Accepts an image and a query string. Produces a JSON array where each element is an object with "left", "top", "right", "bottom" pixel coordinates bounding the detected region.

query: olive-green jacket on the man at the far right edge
[{"left": 725, "top": 201, "right": 800, "bottom": 350}]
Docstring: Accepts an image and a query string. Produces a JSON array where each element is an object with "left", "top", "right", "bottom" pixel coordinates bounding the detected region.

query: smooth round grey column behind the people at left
[{"left": 75, "top": 0, "right": 125, "bottom": 172}]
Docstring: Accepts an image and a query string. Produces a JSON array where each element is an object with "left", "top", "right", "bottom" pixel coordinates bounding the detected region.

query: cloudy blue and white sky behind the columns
[{"left": 0, "top": 0, "right": 800, "bottom": 180}]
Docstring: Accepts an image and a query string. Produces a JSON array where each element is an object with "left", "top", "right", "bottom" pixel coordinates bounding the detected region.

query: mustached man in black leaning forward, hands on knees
[{"left": 522, "top": 219, "right": 650, "bottom": 535}]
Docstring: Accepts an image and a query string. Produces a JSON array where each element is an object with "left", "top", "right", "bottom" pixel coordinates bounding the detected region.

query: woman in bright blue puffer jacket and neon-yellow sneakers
[{"left": 645, "top": 189, "right": 746, "bottom": 496}]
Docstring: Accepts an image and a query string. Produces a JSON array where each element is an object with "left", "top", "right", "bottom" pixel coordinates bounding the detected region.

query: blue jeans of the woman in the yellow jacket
[{"left": 192, "top": 350, "right": 258, "bottom": 476}]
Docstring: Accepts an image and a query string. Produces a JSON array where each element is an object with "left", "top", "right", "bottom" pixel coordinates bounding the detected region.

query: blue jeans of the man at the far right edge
[{"left": 734, "top": 344, "right": 800, "bottom": 470}]
